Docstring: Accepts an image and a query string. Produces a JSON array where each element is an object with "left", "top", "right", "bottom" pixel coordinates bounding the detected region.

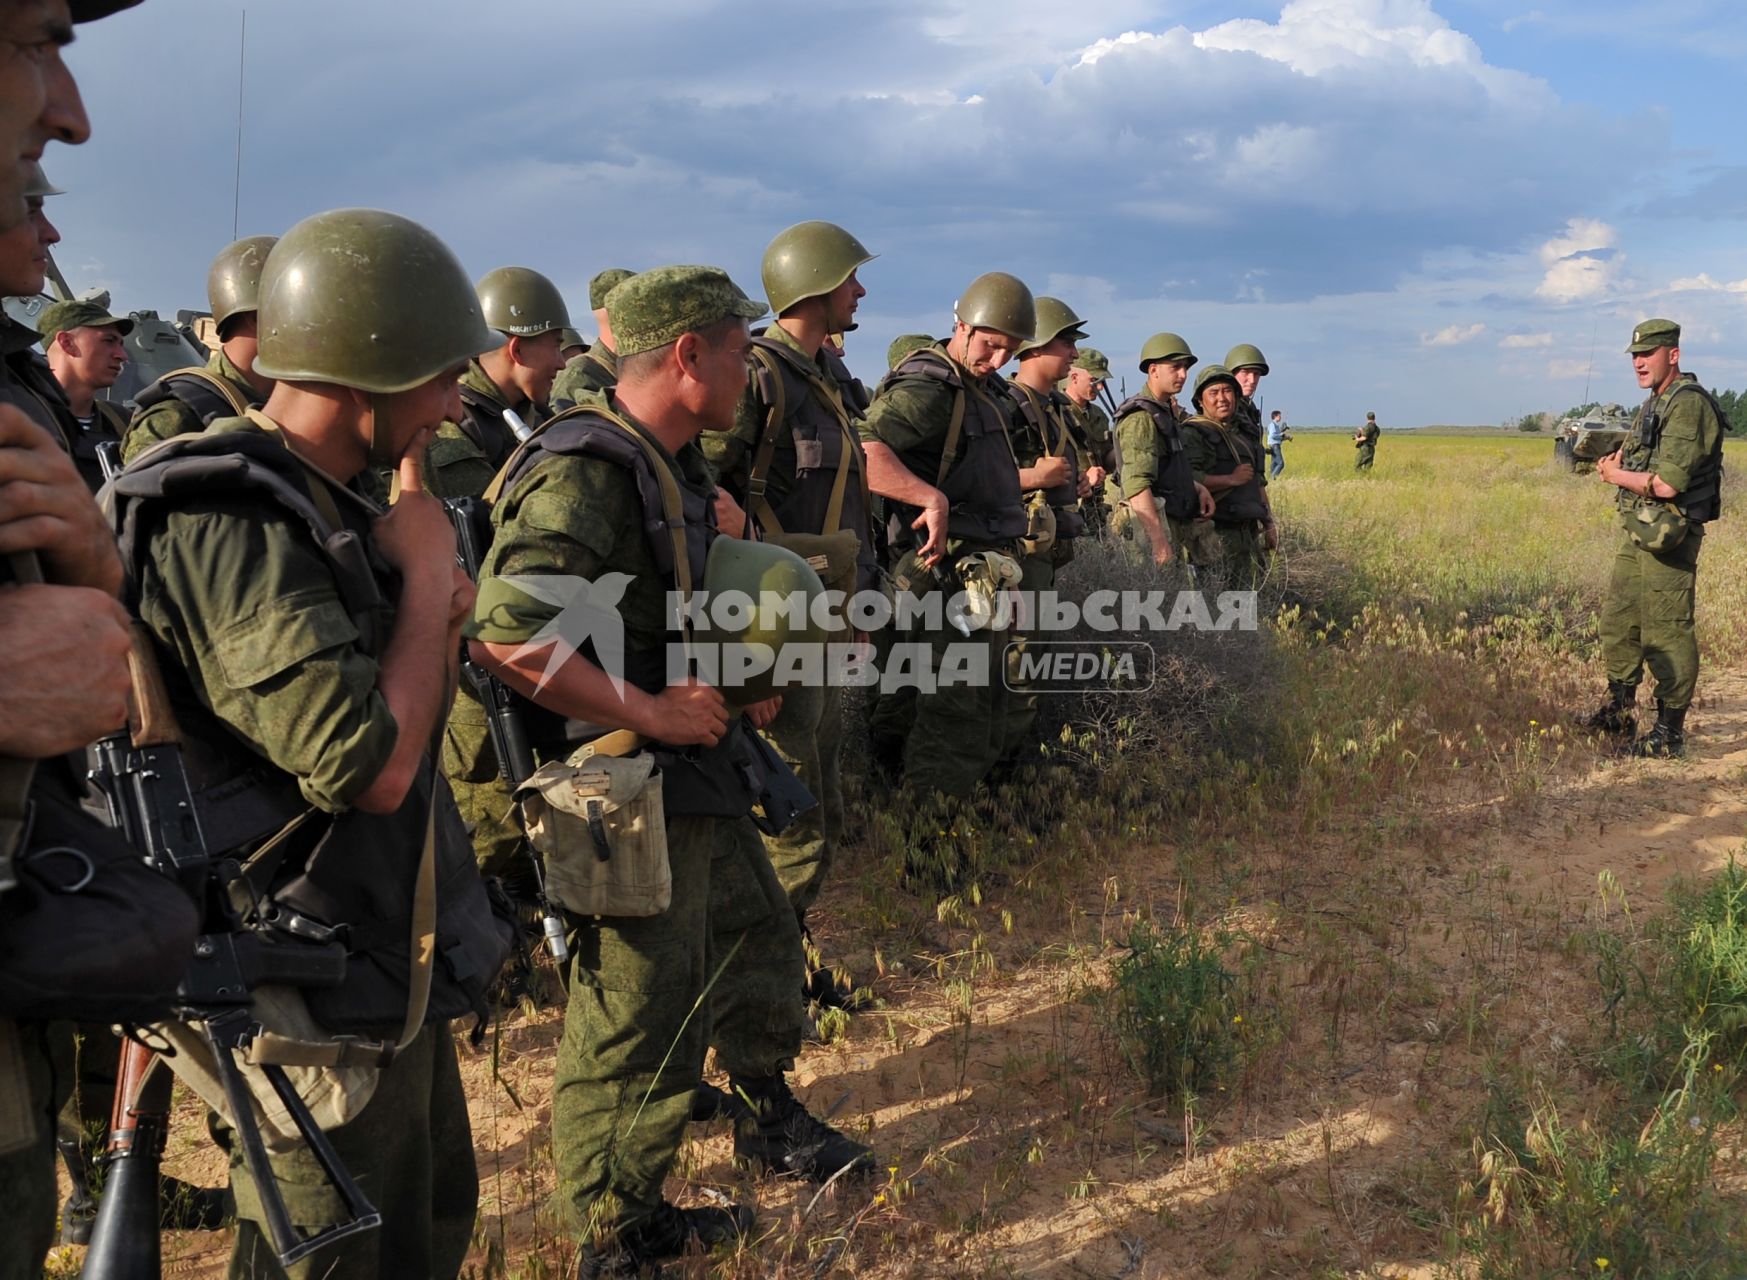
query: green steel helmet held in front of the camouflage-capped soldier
[{"left": 701, "top": 536, "right": 828, "bottom": 707}]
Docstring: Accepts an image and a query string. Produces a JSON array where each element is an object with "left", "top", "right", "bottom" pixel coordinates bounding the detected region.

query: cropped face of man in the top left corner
[{"left": 0, "top": 0, "right": 91, "bottom": 227}]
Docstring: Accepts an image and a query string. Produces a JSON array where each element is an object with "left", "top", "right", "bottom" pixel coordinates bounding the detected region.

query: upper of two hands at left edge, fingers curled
[{"left": 0, "top": 405, "right": 121, "bottom": 594}]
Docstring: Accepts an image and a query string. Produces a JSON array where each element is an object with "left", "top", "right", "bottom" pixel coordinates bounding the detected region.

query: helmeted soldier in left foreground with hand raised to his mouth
[{"left": 115, "top": 210, "right": 508, "bottom": 1278}]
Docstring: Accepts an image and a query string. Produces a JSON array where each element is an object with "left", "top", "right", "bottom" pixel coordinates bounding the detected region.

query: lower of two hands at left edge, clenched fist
[{"left": 0, "top": 583, "right": 129, "bottom": 760}]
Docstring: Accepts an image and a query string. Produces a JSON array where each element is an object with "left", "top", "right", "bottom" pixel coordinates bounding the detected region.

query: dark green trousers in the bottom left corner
[{"left": 0, "top": 1022, "right": 72, "bottom": 1280}]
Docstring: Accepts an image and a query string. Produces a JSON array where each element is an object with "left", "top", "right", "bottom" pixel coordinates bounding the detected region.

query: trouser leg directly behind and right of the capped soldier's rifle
[{"left": 763, "top": 685, "right": 844, "bottom": 922}]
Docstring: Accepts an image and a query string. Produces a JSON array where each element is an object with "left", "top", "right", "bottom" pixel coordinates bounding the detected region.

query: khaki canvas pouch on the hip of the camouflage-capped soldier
[{"left": 515, "top": 746, "right": 673, "bottom": 917}]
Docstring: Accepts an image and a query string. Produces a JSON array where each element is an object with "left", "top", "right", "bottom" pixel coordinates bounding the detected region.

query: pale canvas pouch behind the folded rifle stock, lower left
[{"left": 152, "top": 985, "right": 383, "bottom": 1156}]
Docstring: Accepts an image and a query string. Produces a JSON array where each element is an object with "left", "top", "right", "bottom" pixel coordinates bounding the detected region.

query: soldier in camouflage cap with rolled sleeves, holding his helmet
[{"left": 470, "top": 267, "right": 868, "bottom": 1275}]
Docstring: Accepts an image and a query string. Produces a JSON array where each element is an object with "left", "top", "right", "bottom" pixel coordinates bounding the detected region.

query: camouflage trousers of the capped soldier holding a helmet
[{"left": 552, "top": 815, "right": 804, "bottom": 1238}]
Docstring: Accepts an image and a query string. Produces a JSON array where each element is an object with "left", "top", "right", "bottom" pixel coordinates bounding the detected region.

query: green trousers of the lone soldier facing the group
[{"left": 1600, "top": 526, "right": 1705, "bottom": 711}]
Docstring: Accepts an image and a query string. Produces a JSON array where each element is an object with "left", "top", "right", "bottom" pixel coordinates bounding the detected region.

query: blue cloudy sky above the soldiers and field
[{"left": 45, "top": 0, "right": 1747, "bottom": 426}]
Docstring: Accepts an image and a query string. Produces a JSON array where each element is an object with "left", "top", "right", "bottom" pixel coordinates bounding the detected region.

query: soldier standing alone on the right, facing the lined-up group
[{"left": 1586, "top": 320, "right": 1728, "bottom": 758}]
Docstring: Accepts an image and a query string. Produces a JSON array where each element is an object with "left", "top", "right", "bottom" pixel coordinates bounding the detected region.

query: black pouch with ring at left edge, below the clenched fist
[{"left": 0, "top": 782, "right": 199, "bottom": 1023}]
